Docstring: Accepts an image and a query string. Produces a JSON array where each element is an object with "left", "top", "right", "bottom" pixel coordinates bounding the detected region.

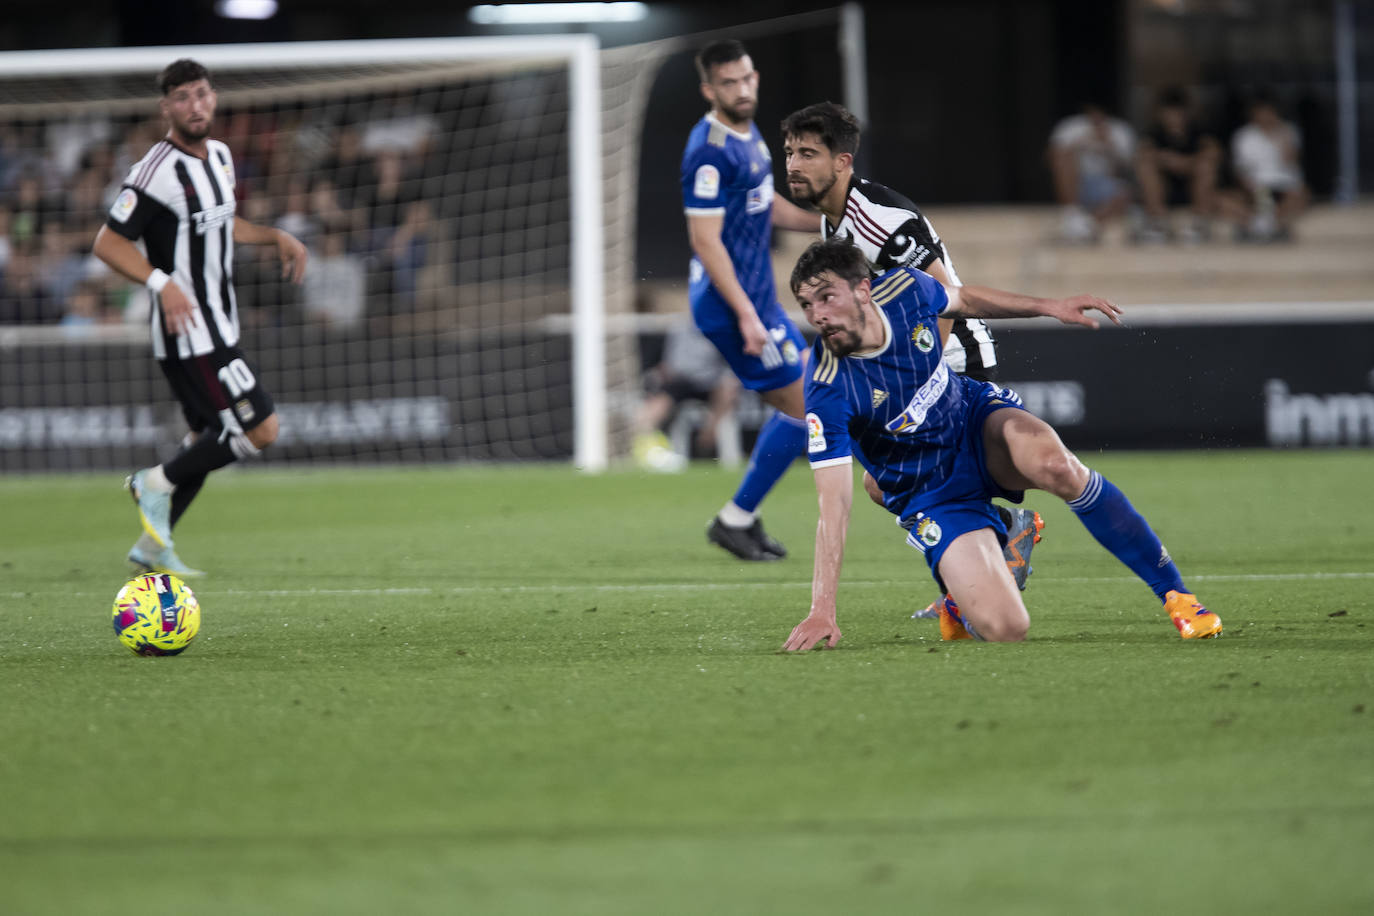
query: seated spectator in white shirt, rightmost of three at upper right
[{"left": 1231, "top": 91, "right": 1312, "bottom": 242}]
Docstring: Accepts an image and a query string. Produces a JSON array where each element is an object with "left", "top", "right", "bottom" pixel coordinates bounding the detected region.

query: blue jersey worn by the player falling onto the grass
[{"left": 807, "top": 268, "right": 1014, "bottom": 519}]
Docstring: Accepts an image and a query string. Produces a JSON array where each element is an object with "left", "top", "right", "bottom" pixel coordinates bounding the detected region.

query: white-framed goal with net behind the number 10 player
[{"left": 0, "top": 36, "right": 618, "bottom": 471}]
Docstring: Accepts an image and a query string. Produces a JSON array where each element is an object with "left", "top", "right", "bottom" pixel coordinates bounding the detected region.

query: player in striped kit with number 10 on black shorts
[{"left": 95, "top": 58, "right": 306, "bottom": 575}]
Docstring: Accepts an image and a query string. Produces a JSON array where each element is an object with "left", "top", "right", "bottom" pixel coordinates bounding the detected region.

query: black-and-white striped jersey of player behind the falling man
[{"left": 820, "top": 176, "right": 998, "bottom": 380}]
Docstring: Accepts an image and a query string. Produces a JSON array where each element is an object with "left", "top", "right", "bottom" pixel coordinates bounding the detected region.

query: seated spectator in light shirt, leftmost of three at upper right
[{"left": 1048, "top": 102, "right": 1135, "bottom": 243}]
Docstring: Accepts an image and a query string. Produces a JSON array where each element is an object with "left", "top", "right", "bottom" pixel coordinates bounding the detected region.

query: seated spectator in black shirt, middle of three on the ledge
[{"left": 1136, "top": 87, "right": 1221, "bottom": 242}]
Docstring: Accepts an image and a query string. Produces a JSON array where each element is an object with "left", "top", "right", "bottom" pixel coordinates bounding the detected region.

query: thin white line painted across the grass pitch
[{"left": 7, "top": 570, "right": 1374, "bottom": 599}]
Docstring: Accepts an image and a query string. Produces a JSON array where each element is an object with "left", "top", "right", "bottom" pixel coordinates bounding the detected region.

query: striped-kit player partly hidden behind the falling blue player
[{"left": 782, "top": 102, "right": 1044, "bottom": 617}]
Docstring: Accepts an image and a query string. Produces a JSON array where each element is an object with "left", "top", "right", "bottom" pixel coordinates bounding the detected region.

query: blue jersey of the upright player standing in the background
[{"left": 682, "top": 114, "right": 778, "bottom": 318}]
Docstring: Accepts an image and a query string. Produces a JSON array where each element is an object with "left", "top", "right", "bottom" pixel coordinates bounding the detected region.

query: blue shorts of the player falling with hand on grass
[{"left": 901, "top": 378, "right": 1025, "bottom": 589}]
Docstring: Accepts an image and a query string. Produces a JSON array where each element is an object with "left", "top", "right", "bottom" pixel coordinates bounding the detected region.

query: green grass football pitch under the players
[{"left": 0, "top": 450, "right": 1374, "bottom": 916}]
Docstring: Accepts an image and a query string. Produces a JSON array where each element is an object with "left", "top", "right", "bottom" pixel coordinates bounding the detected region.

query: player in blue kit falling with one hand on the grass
[{"left": 783, "top": 239, "right": 1221, "bottom": 651}]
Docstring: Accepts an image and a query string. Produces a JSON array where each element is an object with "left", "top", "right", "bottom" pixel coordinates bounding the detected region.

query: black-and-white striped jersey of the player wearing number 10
[{"left": 106, "top": 140, "right": 239, "bottom": 360}]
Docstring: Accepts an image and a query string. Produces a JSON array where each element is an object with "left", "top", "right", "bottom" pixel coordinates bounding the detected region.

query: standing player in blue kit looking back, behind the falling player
[{"left": 682, "top": 41, "right": 820, "bottom": 560}]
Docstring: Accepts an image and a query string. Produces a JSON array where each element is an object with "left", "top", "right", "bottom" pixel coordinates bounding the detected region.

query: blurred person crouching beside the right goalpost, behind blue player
[{"left": 633, "top": 316, "right": 739, "bottom": 472}]
